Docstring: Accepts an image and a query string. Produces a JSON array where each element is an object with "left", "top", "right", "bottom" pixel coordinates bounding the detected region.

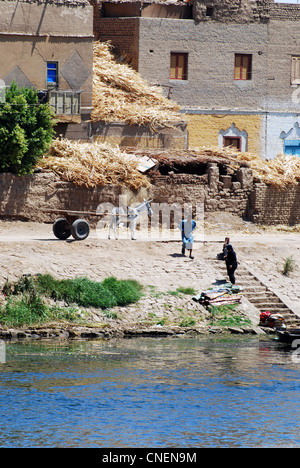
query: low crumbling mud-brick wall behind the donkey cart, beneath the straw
[{"left": 0, "top": 164, "right": 300, "bottom": 225}]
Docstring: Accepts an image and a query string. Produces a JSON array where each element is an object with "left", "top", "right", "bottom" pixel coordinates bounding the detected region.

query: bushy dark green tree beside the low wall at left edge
[{"left": 0, "top": 82, "right": 54, "bottom": 175}]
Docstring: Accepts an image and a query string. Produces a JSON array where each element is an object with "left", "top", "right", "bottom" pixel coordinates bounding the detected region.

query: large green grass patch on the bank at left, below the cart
[{"left": 0, "top": 274, "right": 143, "bottom": 326}]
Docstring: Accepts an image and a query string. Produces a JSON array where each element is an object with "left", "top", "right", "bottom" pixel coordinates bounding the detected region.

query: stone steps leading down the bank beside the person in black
[{"left": 215, "top": 260, "right": 300, "bottom": 326}]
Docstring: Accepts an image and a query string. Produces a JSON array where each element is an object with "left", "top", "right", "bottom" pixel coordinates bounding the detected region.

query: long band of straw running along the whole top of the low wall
[{"left": 39, "top": 139, "right": 300, "bottom": 190}]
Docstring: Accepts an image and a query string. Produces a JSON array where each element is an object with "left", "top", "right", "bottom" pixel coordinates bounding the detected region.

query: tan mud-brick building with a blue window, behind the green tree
[{"left": 0, "top": 0, "right": 93, "bottom": 138}]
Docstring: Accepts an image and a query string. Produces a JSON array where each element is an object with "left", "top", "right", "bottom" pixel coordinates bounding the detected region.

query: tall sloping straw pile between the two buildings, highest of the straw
[{"left": 91, "top": 42, "right": 183, "bottom": 129}]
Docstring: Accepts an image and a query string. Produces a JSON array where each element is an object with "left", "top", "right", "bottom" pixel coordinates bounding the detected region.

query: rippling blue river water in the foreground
[{"left": 0, "top": 336, "right": 300, "bottom": 448}]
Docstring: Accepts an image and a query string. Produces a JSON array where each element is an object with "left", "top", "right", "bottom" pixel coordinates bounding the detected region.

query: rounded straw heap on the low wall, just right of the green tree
[{"left": 39, "top": 139, "right": 149, "bottom": 190}]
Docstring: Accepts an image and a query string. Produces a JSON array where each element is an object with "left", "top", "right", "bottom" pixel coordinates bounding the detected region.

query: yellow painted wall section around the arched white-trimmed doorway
[{"left": 186, "top": 114, "right": 262, "bottom": 155}]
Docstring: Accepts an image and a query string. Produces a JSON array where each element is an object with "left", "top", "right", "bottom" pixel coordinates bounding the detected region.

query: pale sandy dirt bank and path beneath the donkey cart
[{"left": 0, "top": 213, "right": 300, "bottom": 326}]
